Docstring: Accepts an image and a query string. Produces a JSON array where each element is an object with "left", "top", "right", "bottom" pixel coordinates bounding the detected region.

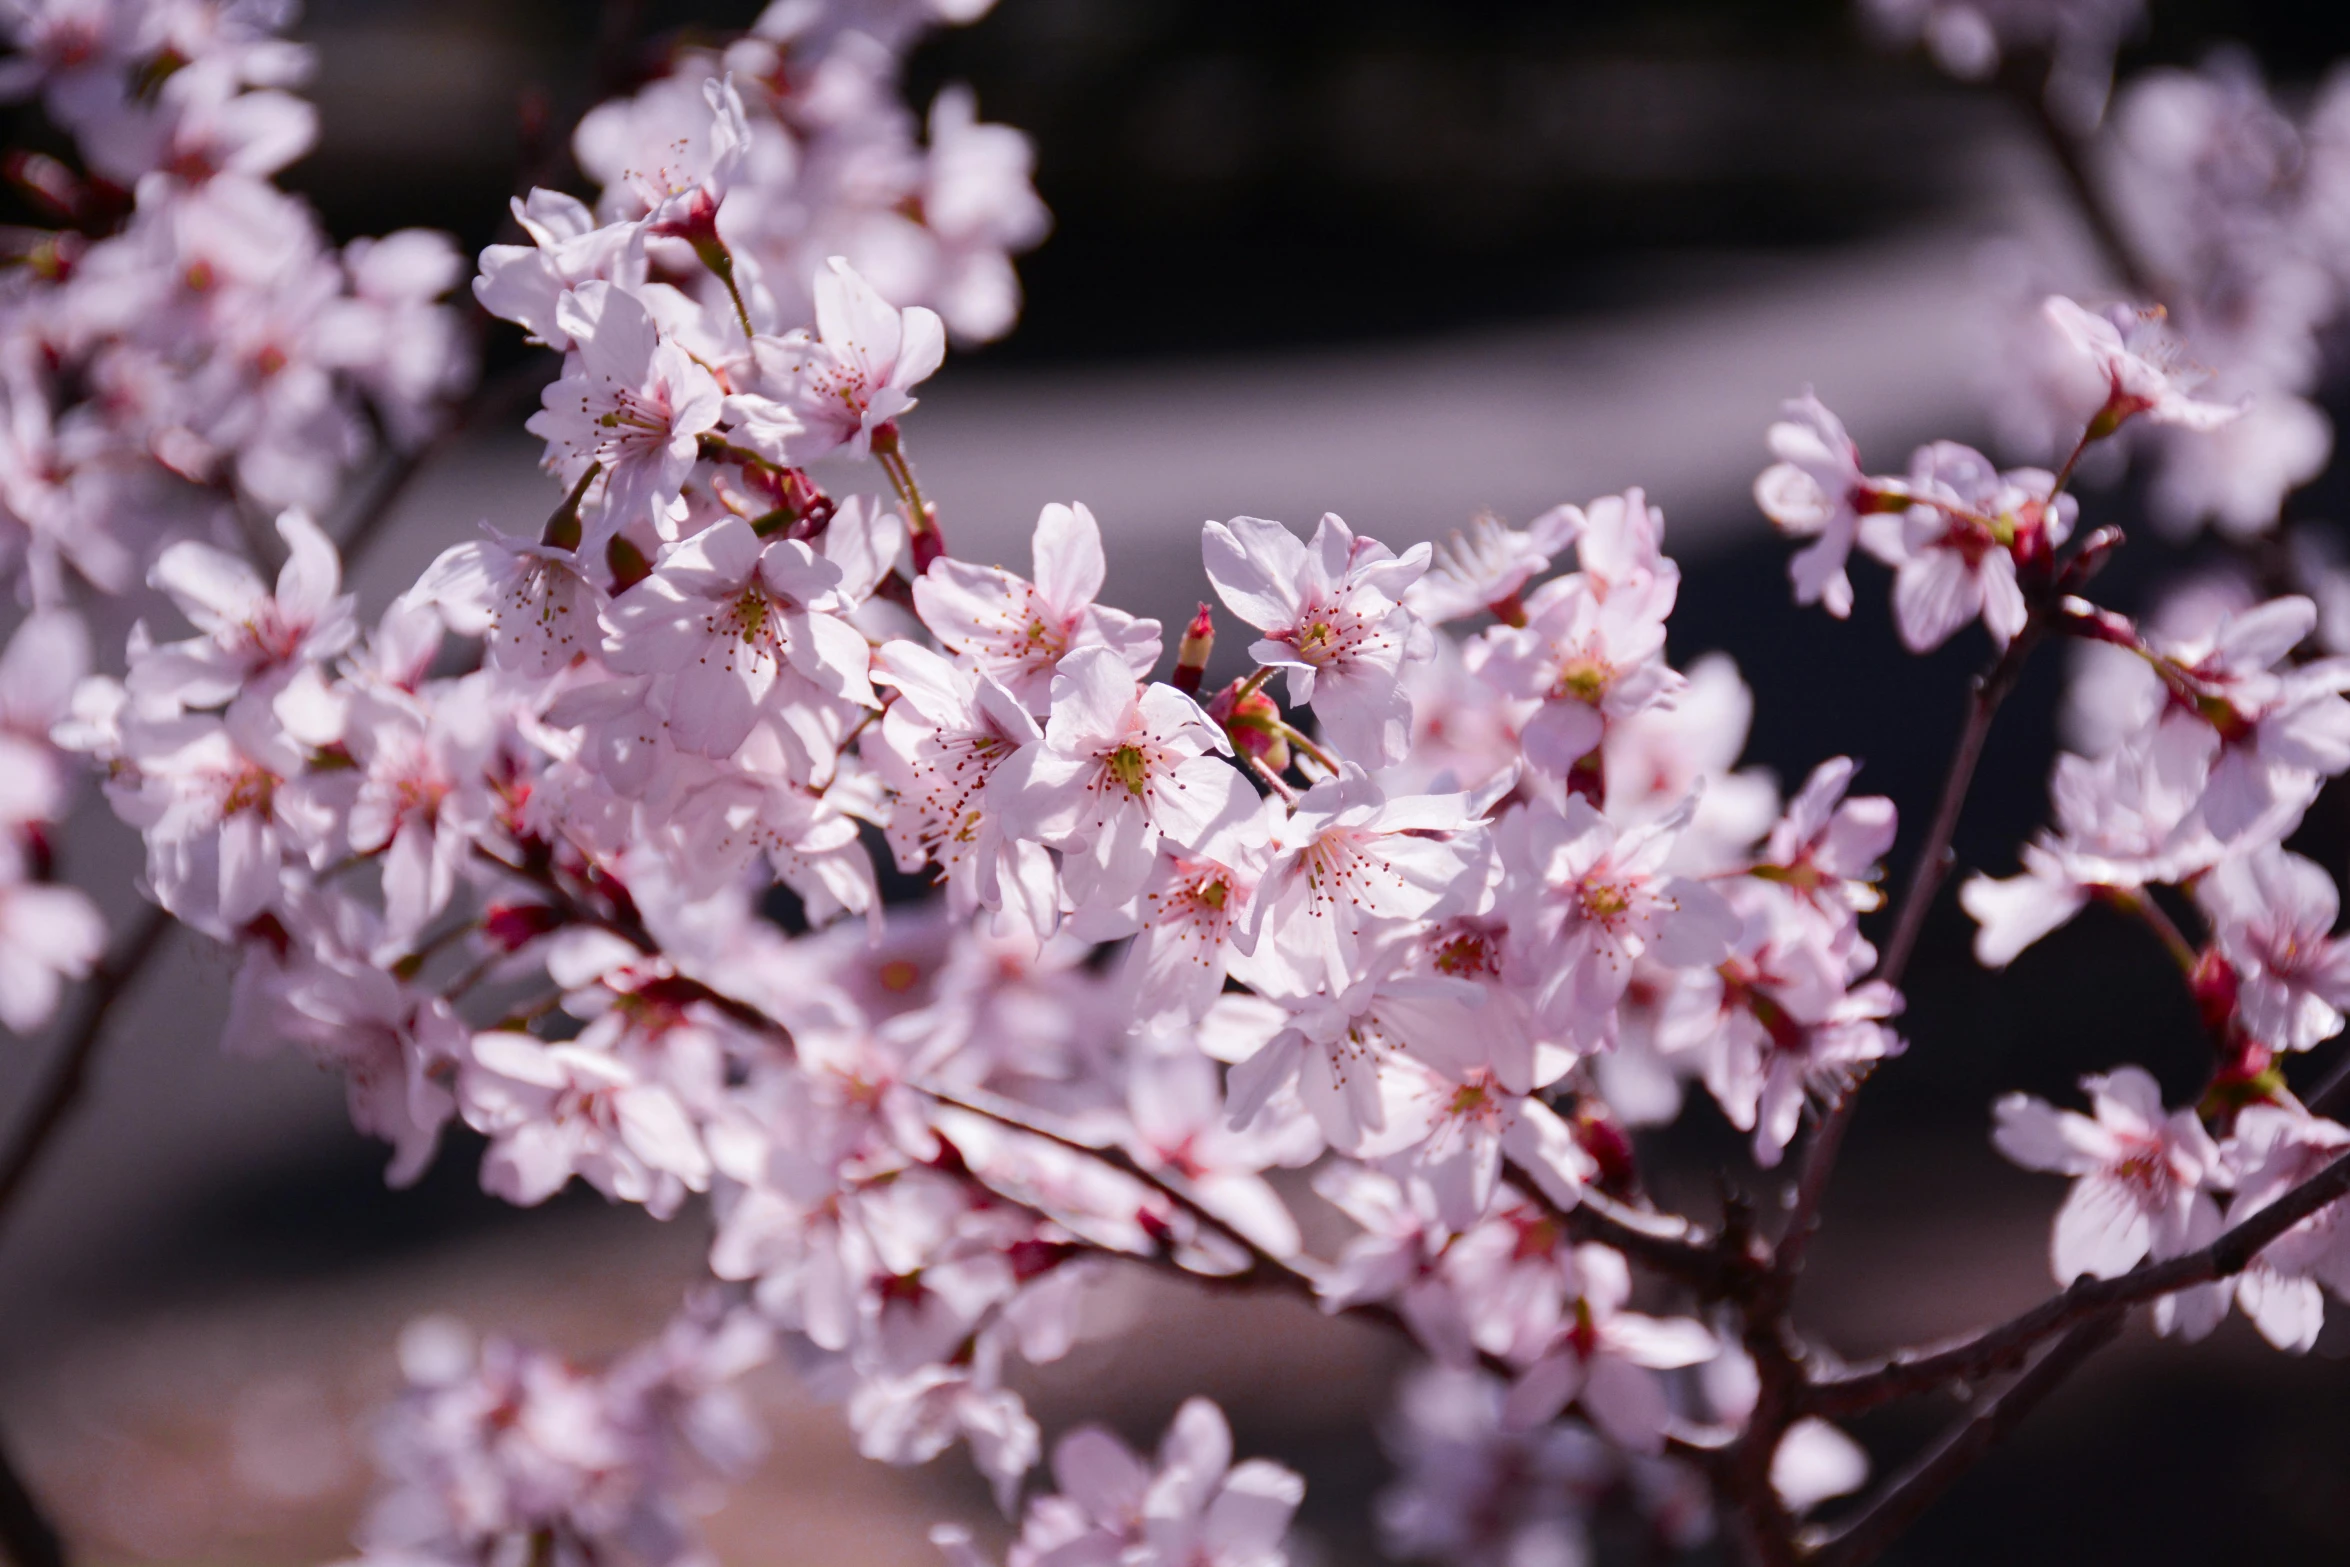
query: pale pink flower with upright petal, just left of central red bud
[{"left": 914, "top": 503, "right": 1159, "bottom": 712}]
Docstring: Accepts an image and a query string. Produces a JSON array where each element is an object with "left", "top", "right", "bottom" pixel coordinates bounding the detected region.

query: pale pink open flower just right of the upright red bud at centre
[{"left": 1201, "top": 515, "right": 1431, "bottom": 768}]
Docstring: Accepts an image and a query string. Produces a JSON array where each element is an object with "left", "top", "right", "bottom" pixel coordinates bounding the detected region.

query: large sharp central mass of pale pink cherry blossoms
[{"left": 66, "top": 42, "right": 1936, "bottom": 1550}]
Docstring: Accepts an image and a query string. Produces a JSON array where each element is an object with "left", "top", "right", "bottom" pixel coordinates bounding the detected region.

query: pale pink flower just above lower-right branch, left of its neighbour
[{"left": 1990, "top": 1067, "right": 2221, "bottom": 1285}]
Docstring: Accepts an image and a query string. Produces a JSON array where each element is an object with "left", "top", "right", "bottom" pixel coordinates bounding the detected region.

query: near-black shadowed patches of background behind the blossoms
[{"left": 22, "top": 0, "right": 2350, "bottom": 1567}]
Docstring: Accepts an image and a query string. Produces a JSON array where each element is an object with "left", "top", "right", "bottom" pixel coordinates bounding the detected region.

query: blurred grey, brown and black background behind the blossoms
[{"left": 13, "top": 0, "right": 2350, "bottom": 1567}]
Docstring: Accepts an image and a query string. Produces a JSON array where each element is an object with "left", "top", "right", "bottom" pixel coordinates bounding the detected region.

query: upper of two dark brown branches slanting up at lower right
[{"left": 1802, "top": 1154, "right": 2350, "bottom": 1417}]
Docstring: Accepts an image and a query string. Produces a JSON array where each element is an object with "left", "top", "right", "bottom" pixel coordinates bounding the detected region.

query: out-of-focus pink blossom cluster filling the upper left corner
[{"left": 0, "top": 0, "right": 472, "bottom": 606}]
